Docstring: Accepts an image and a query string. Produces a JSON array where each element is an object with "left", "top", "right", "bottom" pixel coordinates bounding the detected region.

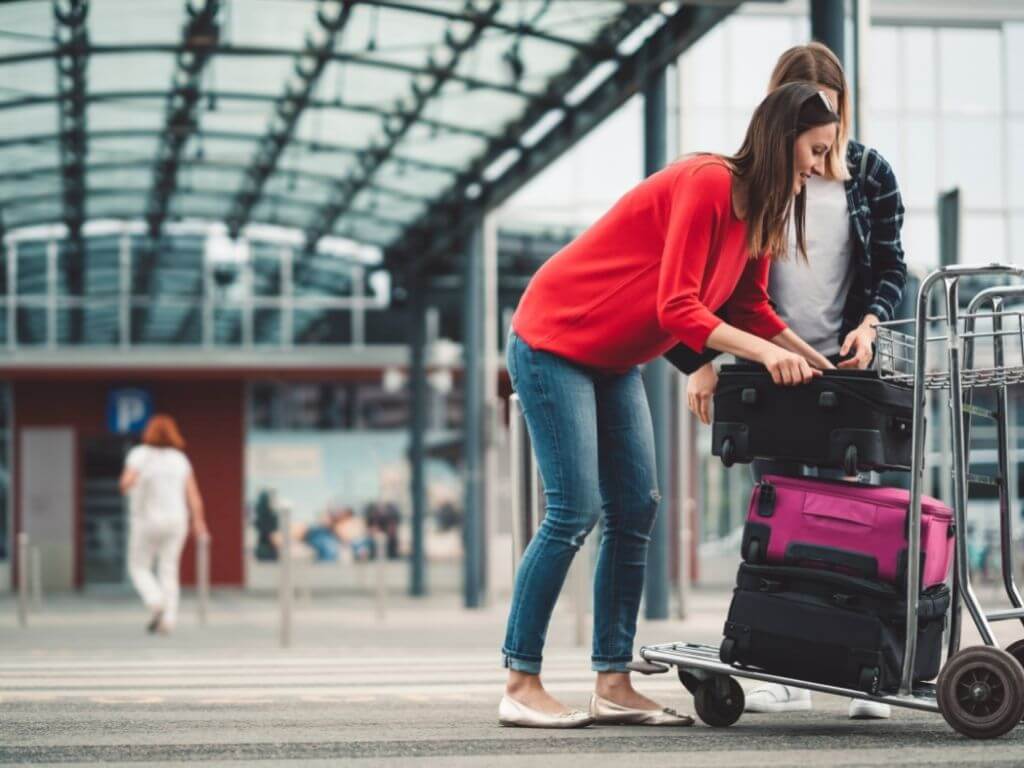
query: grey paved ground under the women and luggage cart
[{"left": 0, "top": 590, "right": 1024, "bottom": 768}]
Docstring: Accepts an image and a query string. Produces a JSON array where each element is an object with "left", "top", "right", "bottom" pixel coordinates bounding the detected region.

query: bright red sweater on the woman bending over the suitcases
[{"left": 512, "top": 156, "right": 785, "bottom": 371}]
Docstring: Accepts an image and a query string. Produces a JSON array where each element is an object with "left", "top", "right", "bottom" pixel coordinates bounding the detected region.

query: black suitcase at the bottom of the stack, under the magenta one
[{"left": 720, "top": 563, "right": 949, "bottom": 693}]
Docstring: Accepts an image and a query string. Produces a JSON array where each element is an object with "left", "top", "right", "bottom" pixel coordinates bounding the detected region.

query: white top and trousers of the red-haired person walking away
[{"left": 125, "top": 445, "right": 193, "bottom": 628}]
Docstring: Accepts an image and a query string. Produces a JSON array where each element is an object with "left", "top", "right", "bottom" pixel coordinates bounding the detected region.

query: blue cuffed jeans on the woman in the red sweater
[{"left": 502, "top": 333, "right": 660, "bottom": 674}]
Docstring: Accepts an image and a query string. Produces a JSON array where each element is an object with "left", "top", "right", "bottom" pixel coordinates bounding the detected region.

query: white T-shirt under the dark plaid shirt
[{"left": 768, "top": 176, "right": 854, "bottom": 356}]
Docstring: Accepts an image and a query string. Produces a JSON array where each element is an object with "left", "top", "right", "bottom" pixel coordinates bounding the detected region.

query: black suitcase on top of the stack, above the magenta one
[{"left": 712, "top": 364, "right": 913, "bottom": 475}]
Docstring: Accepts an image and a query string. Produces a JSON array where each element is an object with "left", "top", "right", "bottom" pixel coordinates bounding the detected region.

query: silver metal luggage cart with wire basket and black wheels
[{"left": 632, "top": 264, "right": 1024, "bottom": 738}]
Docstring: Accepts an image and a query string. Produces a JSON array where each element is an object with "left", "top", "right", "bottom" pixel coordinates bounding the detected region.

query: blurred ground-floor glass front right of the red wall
[{"left": 245, "top": 378, "right": 464, "bottom": 589}]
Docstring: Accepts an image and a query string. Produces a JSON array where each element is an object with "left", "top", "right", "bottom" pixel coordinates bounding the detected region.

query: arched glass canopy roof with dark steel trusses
[{"left": 0, "top": 0, "right": 663, "bottom": 252}]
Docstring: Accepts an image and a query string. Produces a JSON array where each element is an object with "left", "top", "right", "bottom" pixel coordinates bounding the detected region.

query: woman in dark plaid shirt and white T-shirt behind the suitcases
[{"left": 684, "top": 43, "right": 906, "bottom": 718}]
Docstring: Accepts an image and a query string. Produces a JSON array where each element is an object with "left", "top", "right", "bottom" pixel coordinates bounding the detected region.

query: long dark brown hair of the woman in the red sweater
[{"left": 723, "top": 83, "right": 839, "bottom": 260}]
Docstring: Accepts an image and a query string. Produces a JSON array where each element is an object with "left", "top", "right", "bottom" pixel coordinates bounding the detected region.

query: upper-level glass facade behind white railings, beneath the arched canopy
[{"left": 0, "top": 222, "right": 390, "bottom": 348}]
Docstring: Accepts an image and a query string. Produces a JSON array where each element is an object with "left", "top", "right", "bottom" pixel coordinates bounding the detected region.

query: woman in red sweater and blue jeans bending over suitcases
[{"left": 499, "top": 83, "right": 839, "bottom": 728}]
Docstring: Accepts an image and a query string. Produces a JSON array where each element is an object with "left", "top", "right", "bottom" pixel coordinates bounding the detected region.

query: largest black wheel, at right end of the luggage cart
[{"left": 936, "top": 645, "right": 1024, "bottom": 738}]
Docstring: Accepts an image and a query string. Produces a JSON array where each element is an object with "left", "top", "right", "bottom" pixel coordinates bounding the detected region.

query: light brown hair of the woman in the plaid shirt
[{"left": 768, "top": 42, "right": 853, "bottom": 181}]
